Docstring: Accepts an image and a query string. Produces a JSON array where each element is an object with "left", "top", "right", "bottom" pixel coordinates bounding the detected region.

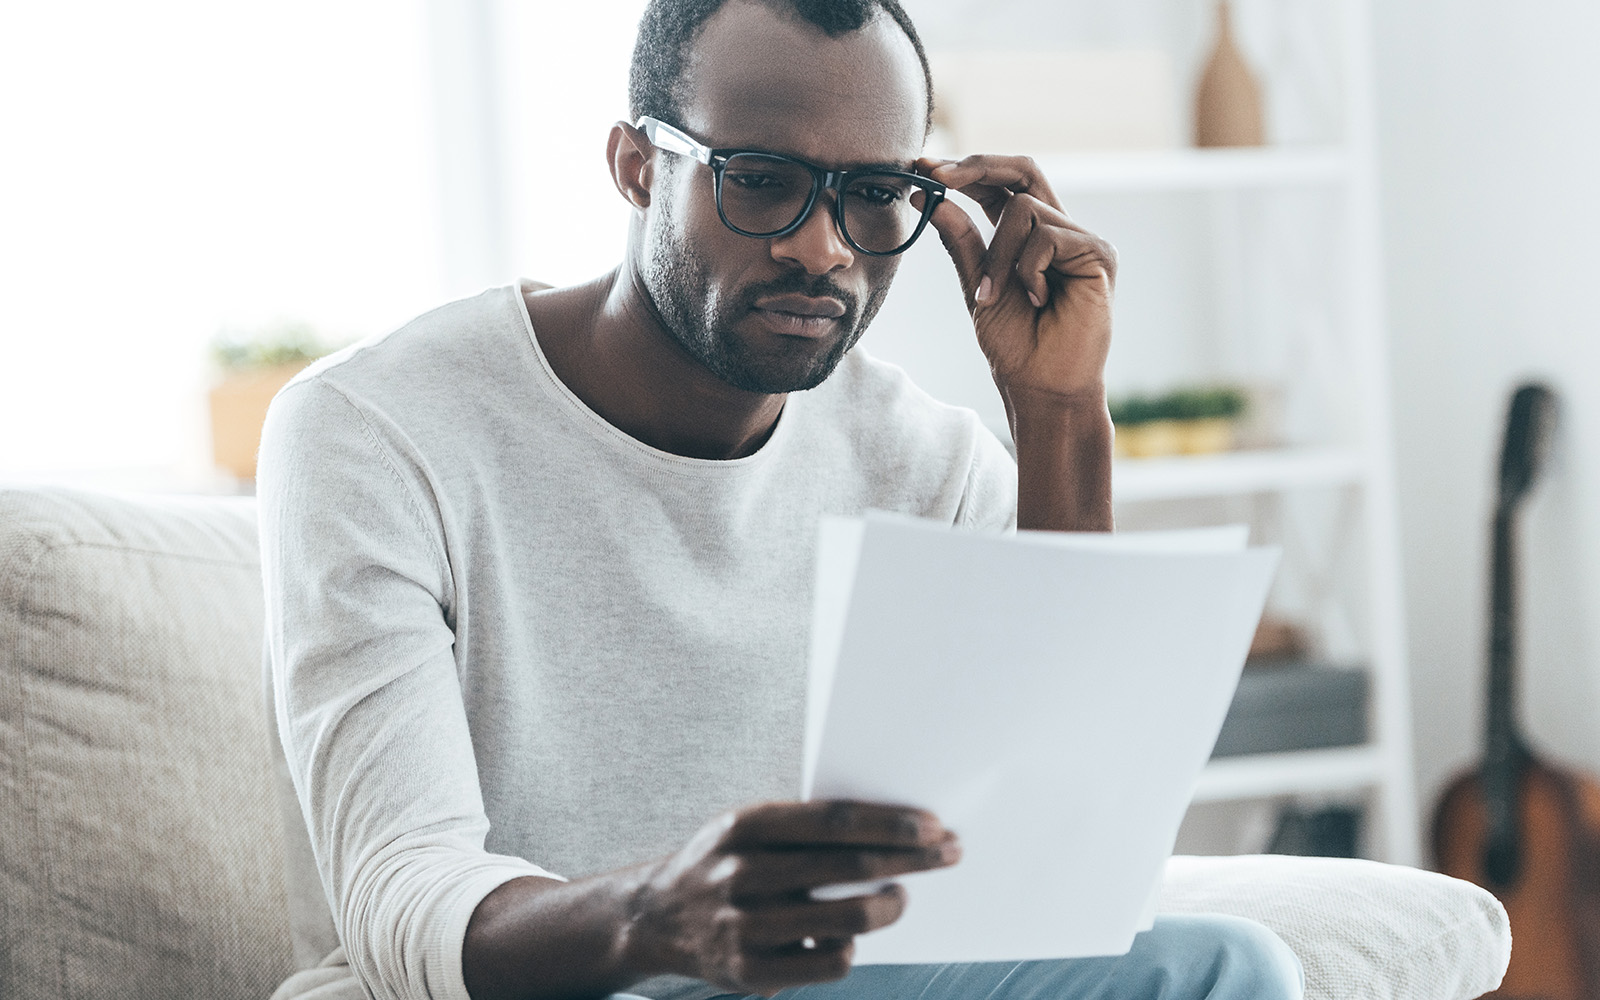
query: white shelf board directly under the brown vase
[{"left": 1037, "top": 146, "right": 1350, "bottom": 194}]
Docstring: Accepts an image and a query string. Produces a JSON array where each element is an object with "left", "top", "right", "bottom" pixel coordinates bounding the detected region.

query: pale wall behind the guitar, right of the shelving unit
[{"left": 1374, "top": 0, "right": 1600, "bottom": 825}]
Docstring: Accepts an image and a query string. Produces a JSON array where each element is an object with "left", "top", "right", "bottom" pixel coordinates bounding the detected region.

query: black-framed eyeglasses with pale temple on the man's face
[{"left": 637, "top": 115, "right": 944, "bottom": 258}]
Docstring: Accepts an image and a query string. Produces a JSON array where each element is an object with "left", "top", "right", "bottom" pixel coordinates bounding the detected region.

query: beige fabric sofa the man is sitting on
[{"left": 0, "top": 486, "right": 1510, "bottom": 1000}]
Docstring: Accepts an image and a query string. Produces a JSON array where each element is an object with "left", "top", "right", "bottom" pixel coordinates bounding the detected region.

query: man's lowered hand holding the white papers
[{"left": 624, "top": 800, "right": 962, "bottom": 995}]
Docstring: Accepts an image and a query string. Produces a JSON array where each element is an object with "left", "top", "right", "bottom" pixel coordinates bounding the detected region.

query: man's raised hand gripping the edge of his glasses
[{"left": 917, "top": 155, "right": 1117, "bottom": 402}]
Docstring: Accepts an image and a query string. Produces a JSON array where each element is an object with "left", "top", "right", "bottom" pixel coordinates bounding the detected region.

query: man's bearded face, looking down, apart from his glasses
[{"left": 640, "top": 0, "right": 926, "bottom": 394}]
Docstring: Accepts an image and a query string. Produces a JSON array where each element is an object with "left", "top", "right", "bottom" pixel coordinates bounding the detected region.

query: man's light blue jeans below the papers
[{"left": 613, "top": 915, "right": 1304, "bottom": 1000}]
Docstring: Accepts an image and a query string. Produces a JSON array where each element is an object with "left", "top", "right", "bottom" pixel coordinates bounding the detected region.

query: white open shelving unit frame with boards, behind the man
[{"left": 1075, "top": 0, "right": 1419, "bottom": 864}]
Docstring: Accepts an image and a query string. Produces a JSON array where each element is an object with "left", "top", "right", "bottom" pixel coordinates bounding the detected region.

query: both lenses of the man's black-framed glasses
[{"left": 720, "top": 154, "right": 922, "bottom": 253}]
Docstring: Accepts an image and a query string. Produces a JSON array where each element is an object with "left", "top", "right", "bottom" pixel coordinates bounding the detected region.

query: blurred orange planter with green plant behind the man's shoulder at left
[{"left": 211, "top": 323, "right": 328, "bottom": 480}]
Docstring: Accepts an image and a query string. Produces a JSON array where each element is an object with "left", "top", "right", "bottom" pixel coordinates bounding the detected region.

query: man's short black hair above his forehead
[{"left": 627, "top": 0, "right": 933, "bottom": 131}]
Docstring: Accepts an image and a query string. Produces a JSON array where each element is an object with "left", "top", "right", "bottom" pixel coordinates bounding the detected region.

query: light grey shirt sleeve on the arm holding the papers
[{"left": 258, "top": 376, "right": 554, "bottom": 1000}]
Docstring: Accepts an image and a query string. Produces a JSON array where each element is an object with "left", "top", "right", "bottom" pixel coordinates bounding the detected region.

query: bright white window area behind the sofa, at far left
[{"left": 0, "top": 0, "right": 440, "bottom": 488}]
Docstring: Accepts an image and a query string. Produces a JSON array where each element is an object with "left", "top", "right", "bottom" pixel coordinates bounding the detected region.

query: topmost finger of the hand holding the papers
[{"left": 723, "top": 798, "right": 946, "bottom": 848}]
